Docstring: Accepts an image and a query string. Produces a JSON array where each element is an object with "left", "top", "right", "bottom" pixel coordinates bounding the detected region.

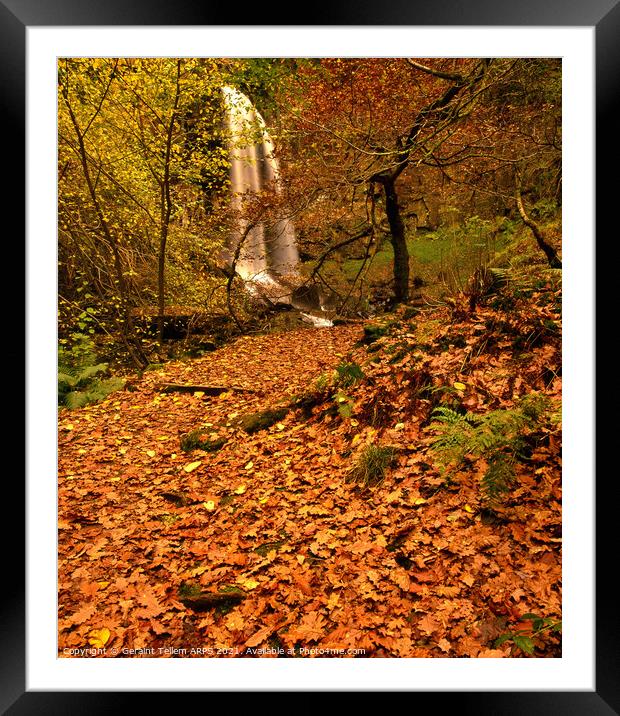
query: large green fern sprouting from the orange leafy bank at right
[{"left": 431, "top": 393, "right": 558, "bottom": 505}]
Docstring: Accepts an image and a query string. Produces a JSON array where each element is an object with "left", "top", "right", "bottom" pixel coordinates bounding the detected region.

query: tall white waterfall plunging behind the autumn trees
[{"left": 222, "top": 87, "right": 299, "bottom": 298}]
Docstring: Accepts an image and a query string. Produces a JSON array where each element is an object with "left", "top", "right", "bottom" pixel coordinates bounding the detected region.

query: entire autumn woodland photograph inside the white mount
[{"left": 58, "top": 57, "right": 562, "bottom": 658}]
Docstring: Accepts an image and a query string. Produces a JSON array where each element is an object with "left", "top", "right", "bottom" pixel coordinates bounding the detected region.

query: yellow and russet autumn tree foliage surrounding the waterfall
[{"left": 58, "top": 58, "right": 561, "bottom": 364}]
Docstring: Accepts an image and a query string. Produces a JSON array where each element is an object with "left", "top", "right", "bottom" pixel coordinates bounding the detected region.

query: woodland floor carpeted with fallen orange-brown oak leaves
[{"left": 59, "top": 289, "right": 561, "bottom": 657}]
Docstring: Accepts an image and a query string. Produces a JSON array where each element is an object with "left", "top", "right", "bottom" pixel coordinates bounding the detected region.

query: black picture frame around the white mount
[{"left": 7, "top": 0, "right": 608, "bottom": 716}]
